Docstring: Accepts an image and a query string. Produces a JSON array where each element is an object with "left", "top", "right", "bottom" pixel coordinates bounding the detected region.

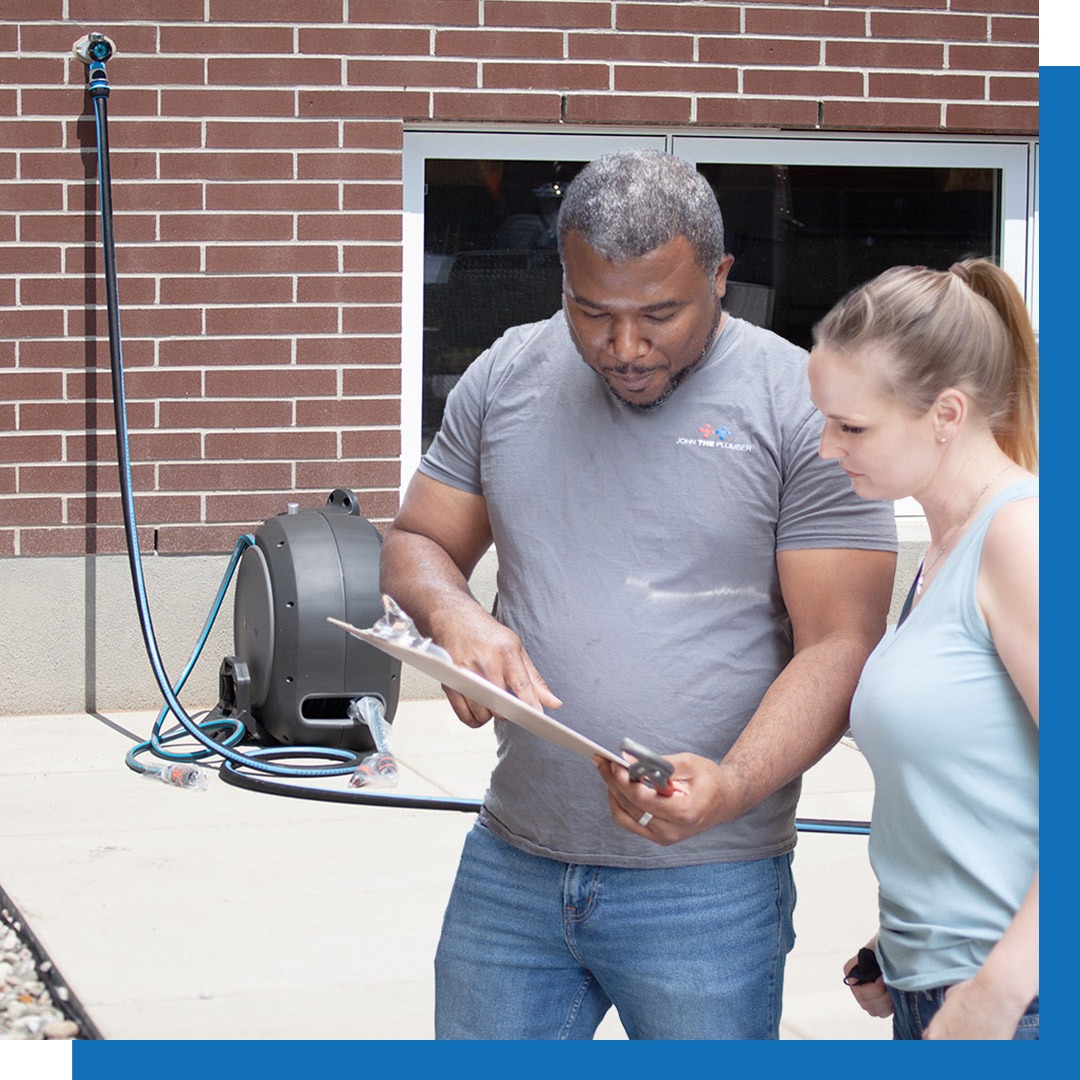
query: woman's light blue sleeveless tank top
[{"left": 851, "top": 477, "right": 1039, "bottom": 990}]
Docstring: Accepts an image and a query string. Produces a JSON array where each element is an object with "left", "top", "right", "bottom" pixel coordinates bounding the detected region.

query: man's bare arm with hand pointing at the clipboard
[{"left": 379, "top": 473, "right": 562, "bottom": 727}]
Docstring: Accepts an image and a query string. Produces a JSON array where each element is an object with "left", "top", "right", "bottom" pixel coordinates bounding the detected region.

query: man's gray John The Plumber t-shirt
[{"left": 420, "top": 312, "right": 896, "bottom": 867}]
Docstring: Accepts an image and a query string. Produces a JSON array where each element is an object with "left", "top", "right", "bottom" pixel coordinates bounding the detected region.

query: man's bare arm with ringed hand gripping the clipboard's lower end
[{"left": 598, "top": 549, "right": 896, "bottom": 845}]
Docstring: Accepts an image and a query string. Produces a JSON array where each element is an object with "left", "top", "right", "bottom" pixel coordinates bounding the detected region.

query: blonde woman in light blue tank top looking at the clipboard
[{"left": 809, "top": 259, "right": 1039, "bottom": 1039}]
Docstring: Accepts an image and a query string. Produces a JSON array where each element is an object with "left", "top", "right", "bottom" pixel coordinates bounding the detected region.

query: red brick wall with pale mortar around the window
[{"left": 0, "top": 0, "right": 1038, "bottom": 556}]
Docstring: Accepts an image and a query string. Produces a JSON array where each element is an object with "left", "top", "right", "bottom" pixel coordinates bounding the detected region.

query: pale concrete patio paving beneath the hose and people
[{"left": 0, "top": 699, "right": 890, "bottom": 1040}]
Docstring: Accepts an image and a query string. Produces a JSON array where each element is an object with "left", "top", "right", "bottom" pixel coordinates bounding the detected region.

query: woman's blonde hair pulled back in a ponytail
[{"left": 813, "top": 259, "right": 1039, "bottom": 472}]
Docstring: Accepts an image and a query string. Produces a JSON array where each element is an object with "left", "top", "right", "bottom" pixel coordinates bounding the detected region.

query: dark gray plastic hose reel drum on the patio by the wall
[{"left": 219, "top": 487, "right": 401, "bottom": 752}]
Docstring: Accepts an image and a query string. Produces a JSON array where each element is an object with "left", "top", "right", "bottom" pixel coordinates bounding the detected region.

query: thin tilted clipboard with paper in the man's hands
[{"left": 327, "top": 618, "right": 627, "bottom": 766}]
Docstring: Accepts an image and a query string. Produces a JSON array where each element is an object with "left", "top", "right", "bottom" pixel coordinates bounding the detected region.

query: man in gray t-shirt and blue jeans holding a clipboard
[{"left": 382, "top": 151, "right": 895, "bottom": 1039}]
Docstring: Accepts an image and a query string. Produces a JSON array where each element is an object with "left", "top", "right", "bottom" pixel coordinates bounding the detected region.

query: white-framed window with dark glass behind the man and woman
[{"left": 402, "top": 132, "right": 1037, "bottom": 503}]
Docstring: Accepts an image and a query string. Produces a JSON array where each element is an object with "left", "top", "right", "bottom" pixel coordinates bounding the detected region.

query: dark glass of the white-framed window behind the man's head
[{"left": 422, "top": 159, "right": 1001, "bottom": 449}]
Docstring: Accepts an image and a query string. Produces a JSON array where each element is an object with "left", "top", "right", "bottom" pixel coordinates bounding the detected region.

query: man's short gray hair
[{"left": 557, "top": 150, "right": 724, "bottom": 276}]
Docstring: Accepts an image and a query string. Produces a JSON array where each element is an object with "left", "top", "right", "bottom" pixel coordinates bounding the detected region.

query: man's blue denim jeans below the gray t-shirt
[{"left": 435, "top": 822, "right": 795, "bottom": 1039}]
